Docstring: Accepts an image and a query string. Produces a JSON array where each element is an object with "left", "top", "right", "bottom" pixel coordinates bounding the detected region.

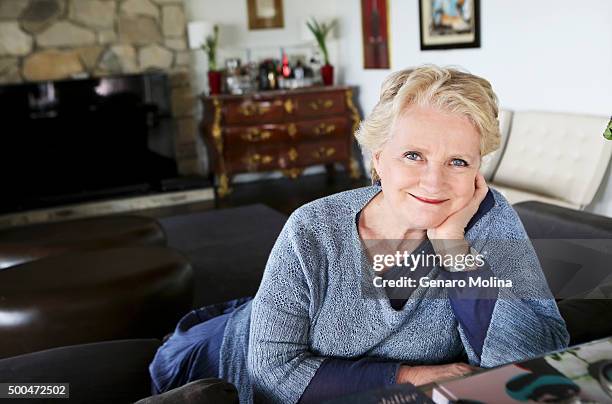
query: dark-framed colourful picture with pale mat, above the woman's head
[{"left": 419, "top": 0, "right": 480, "bottom": 50}]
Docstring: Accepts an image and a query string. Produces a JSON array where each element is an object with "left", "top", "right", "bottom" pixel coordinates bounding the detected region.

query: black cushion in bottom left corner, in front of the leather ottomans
[{"left": 0, "top": 339, "right": 160, "bottom": 404}]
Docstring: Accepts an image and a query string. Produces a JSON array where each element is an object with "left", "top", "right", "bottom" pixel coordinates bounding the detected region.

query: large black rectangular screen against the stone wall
[{"left": 0, "top": 72, "right": 178, "bottom": 213}]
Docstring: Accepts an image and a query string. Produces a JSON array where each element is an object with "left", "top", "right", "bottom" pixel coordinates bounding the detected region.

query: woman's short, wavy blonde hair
[{"left": 355, "top": 65, "right": 501, "bottom": 182}]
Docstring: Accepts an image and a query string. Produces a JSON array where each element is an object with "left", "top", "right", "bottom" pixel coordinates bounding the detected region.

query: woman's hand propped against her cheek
[{"left": 427, "top": 172, "right": 489, "bottom": 240}]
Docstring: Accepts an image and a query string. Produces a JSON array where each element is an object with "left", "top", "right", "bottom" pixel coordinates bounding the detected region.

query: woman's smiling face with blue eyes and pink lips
[{"left": 374, "top": 105, "right": 480, "bottom": 230}]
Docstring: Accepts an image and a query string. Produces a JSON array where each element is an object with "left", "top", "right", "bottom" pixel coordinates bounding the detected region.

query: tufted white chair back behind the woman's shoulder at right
[{"left": 492, "top": 112, "right": 612, "bottom": 208}]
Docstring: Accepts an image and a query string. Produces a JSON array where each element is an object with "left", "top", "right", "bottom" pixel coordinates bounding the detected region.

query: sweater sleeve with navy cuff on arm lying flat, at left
[{"left": 247, "top": 213, "right": 399, "bottom": 403}]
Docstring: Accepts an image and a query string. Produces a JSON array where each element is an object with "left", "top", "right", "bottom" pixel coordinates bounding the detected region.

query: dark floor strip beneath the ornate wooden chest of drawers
[{"left": 137, "top": 172, "right": 370, "bottom": 218}]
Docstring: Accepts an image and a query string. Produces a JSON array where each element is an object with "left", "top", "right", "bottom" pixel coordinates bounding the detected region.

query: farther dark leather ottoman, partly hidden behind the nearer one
[{"left": 0, "top": 215, "right": 166, "bottom": 270}]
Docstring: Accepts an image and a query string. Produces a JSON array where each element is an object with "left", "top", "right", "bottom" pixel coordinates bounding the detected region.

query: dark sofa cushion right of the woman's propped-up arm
[{"left": 513, "top": 201, "right": 612, "bottom": 345}]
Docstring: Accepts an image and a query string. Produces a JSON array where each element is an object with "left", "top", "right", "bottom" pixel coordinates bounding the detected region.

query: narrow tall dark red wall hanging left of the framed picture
[{"left": 361, "top": 0, "right": 390, "bottom": 69}]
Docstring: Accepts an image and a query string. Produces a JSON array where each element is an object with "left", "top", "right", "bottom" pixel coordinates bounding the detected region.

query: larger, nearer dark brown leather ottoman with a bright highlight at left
[{"left": 0, "top": 247, "right": 193, "bottom": 358}]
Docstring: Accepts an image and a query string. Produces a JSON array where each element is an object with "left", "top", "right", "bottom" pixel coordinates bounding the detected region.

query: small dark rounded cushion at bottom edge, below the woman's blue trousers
[{"left": 136, "top": 379, "right": 239, "bottom": 404}]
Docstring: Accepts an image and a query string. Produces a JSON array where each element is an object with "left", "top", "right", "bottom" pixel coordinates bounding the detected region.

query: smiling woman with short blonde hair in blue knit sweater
[{"left": 150, "top": 66, "right": 569, "bottom": 403}]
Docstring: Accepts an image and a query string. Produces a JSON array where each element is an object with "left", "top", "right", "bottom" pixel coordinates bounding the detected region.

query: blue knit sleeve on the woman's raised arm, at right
[{"left": 458, "top": 196, "right": 569, "bottom": 368}]
